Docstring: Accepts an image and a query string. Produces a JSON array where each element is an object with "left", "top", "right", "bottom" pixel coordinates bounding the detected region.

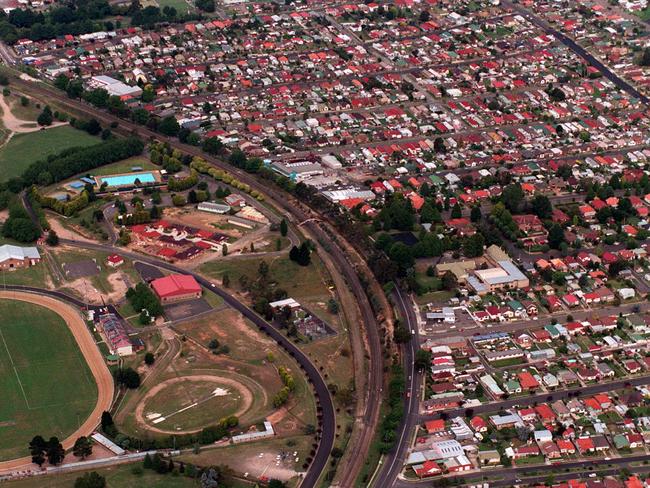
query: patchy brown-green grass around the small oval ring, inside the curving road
[{"left": 116, "top": 307, "right": 316, "bottom": 437}]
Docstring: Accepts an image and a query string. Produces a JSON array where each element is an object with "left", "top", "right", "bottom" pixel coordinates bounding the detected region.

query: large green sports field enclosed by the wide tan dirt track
[{"left": 0, "top": 299, "right": 97, "bottom": 460}]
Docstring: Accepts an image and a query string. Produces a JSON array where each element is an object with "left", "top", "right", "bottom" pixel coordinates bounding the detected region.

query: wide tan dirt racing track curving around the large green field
[{"left": 0, "top": 291, "right": 114, "bottom": 471}]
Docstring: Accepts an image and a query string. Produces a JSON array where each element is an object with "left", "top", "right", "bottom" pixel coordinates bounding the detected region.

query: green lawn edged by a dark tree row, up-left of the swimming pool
[{"left": 0, "top": 125, "right": 101, "bottom": 181}]
